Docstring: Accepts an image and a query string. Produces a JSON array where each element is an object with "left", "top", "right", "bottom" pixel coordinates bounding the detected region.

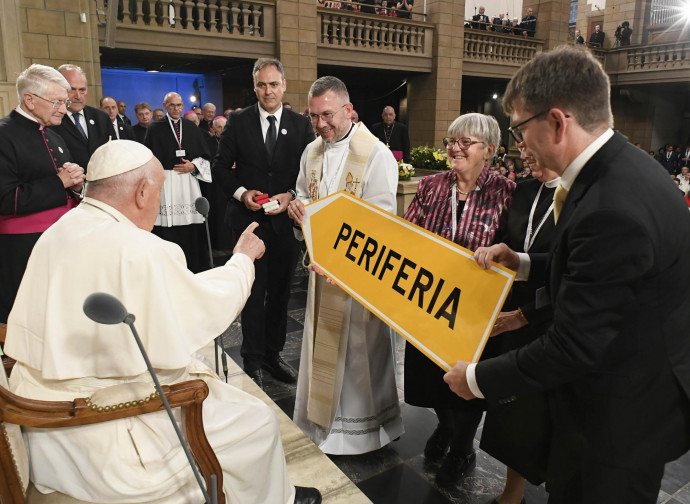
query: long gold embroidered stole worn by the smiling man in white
[{"left": 306, "top": 123, "right": 378, "bottom": 430}]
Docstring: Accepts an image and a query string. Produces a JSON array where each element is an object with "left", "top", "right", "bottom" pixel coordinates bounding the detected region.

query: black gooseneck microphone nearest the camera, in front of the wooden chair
[{"left": 84, "top": 292, "right": 218, "bottom": 504}]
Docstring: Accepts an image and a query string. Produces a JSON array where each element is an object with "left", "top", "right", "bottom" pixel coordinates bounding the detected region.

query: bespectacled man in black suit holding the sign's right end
[{"left": 445, "top": 46, "right": 690, "bottom": 504}]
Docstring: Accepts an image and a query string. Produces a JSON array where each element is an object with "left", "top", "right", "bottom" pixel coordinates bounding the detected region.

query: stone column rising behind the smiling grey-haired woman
[{"left": 407, "top": 0, "right": 465, "bottom": 147}]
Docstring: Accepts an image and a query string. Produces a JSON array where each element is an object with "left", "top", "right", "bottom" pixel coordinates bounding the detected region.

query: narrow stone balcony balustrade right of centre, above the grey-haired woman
[{"left": 462, "top": 30, "right": 544, "bottom": 78}]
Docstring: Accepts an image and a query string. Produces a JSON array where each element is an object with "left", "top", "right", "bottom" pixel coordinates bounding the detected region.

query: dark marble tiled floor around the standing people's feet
[{"left": 216, "top": 260, "right": 690, "bottom": 504}]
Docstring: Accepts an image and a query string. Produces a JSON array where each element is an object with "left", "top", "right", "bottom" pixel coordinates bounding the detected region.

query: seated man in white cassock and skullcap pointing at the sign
[{"left": 5, "top": 140, "right": 321, "bottom": 504}]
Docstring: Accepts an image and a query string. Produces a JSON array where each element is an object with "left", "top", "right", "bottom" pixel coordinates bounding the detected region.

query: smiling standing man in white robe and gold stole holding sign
[{"left": 288, "top": 76, "right": 404, "bottom": 455}]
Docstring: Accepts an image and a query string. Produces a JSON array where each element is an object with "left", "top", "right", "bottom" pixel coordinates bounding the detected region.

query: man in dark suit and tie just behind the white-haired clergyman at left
[{"left": 55, "top": 65, "right": 116, "bottom": 170}]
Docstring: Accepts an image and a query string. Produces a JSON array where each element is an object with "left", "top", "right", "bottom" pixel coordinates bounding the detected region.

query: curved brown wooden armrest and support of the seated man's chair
[{"left": 0, "top": 380, "right": 225, "bottom": 504}]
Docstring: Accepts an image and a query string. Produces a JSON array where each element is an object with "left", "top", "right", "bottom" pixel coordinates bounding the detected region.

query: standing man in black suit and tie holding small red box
[{"left": 213, "top": 58, "right": 314, "bottom": 386}]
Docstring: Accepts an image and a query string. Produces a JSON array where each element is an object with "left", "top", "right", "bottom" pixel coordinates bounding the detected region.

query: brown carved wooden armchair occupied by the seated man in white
[{"left": 0, "top": 378, "right": 225, "bottom": 504}]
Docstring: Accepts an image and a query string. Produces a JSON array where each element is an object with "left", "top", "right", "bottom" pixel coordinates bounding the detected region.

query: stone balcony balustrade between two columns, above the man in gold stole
[{"left": 317, "top": 7, "right": 434, "bottom": 71}]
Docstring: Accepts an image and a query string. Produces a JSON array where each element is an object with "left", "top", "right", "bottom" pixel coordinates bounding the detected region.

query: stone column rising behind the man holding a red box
[{"left": 276, "top": 0, "right": 318, "bottom": 112}]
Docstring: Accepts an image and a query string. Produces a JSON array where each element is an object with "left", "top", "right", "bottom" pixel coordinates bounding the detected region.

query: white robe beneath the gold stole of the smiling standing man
[{"left": 293, "top": 123, "right": 404, "bottom": 455}]
